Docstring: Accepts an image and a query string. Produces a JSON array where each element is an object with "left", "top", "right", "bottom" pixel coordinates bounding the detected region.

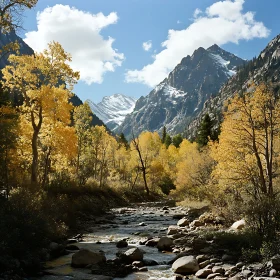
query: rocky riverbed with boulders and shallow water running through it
[{"left": 32, "top": 203, "right": 280, "bottom": 280}]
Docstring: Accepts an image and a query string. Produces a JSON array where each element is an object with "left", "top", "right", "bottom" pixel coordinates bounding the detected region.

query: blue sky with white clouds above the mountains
[{"left": 19, "top": 0, "right": 280, "bottom": 103}]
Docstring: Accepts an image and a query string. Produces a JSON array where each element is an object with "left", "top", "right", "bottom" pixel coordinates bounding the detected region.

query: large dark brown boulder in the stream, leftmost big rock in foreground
[{"left": 71, "top": 249, "right": 106, "bottom": 267}]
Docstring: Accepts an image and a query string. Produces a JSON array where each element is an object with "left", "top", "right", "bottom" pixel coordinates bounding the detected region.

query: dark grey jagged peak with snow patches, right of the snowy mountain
[{"left": 117, "top": 45, "right": 245, "bottom": 138}]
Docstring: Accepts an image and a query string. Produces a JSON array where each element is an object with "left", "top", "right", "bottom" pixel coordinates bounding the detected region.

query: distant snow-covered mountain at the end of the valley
[{"left": 87, "top": 93, "right": 136, "bottom": 131}]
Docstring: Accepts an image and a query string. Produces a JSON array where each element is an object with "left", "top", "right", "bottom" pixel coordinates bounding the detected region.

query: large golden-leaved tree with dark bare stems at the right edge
[{"left": 212, "top": 84, "right": 280, "bottom": 236}]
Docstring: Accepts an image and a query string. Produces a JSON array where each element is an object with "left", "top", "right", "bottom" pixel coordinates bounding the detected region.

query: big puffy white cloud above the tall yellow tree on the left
[{"left": 24, "top": 5, "right": 124, "bottom": 84}]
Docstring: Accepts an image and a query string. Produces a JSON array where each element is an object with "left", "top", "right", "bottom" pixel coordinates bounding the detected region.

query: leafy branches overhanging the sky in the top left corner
[{"left": 0, "top": 0, "right": 38, "bottom": 33}]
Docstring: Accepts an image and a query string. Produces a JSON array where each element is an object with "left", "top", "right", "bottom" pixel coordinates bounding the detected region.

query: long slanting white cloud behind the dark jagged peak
[{"left": 125, "top": 0, "right": 270, "bottom": 87}]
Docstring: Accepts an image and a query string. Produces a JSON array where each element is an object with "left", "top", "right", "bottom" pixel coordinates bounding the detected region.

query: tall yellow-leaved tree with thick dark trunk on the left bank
[{"left": 2, "top": 42, "right": 79, "bottom": 186}]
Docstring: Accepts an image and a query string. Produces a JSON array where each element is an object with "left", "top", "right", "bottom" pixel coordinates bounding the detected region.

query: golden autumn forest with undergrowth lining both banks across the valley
[{"left": 0, "top": 1, "right": 280, "bottom": 278}]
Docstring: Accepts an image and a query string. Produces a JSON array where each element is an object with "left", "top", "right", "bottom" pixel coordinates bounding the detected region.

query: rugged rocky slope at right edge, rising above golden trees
[{"left": 187, "top": 35, "right": 280, "bottom": 139}]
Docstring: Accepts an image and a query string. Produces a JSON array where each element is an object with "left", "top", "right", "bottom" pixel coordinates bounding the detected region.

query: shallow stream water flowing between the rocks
[{"left": 38, "top": 203, "right": 186, "bottom": 280}]
